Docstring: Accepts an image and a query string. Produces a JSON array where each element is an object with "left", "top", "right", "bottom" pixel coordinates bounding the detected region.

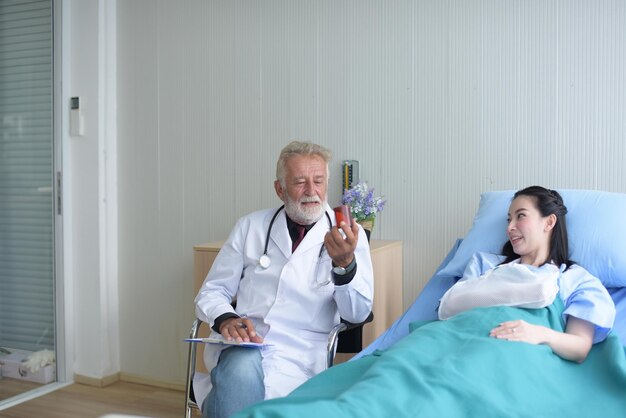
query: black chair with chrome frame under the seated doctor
[{"left": 185, "top": 312, "right": 374, "bottom": 418}]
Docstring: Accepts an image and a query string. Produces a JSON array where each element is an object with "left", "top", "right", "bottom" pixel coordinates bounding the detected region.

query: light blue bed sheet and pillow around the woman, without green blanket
[{"left": 355, "top": 190, "right": 626, "bottom": 358}]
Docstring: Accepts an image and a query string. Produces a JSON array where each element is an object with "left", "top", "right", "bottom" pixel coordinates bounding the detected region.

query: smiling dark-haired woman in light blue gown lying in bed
[{"left": 443, "top": 186, "right": 615, "bottom": 362}]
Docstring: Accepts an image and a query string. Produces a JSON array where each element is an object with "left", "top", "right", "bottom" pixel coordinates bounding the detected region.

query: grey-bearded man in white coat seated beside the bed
[{"left": 195, "top": 142, "right": 373, "bottom": 418}]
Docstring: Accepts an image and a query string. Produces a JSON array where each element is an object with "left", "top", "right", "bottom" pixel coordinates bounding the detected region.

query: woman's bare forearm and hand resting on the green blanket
[{"left": 489, "top": 316, "right": 594, "bottom": 363}]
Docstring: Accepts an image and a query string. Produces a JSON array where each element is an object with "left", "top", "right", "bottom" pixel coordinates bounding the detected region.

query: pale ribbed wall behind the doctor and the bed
[{"left": 118, "top": 0, "right": 626, "bottom": 382}]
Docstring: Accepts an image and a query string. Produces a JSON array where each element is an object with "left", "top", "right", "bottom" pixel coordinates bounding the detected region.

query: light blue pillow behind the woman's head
[{"left": 438, "top": 190, "right": 626, "bottom": 287}]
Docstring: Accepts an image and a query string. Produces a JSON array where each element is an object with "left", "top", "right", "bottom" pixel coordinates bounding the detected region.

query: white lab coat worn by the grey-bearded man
[{"left": 195, "top": 205, "right": 374, "bottom": 399}]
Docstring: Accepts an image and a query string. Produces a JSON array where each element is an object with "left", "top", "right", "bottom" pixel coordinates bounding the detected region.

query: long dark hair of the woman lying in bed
[{"left": 502, "top": 186, "right": 574, "bottom": 268}]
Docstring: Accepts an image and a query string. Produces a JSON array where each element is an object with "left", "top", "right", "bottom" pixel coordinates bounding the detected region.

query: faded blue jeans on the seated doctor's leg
[{"left": 202, "top": 347, "right": 265, "bottom": 418}]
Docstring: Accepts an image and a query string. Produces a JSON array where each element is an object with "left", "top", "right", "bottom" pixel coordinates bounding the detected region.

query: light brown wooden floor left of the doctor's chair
[{"left": 0, "top": 381, "right": 185, "bottom": 418}]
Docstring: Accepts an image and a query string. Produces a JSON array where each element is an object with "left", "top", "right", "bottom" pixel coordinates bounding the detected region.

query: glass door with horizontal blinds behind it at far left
[{"left": 0, "top": 0, "right": 56, "bottom": 406}]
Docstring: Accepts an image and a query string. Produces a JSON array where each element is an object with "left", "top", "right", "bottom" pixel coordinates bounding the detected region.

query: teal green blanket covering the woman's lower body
[{"left": 236, "top": 298, "right": 626, "bottom": 418}]
